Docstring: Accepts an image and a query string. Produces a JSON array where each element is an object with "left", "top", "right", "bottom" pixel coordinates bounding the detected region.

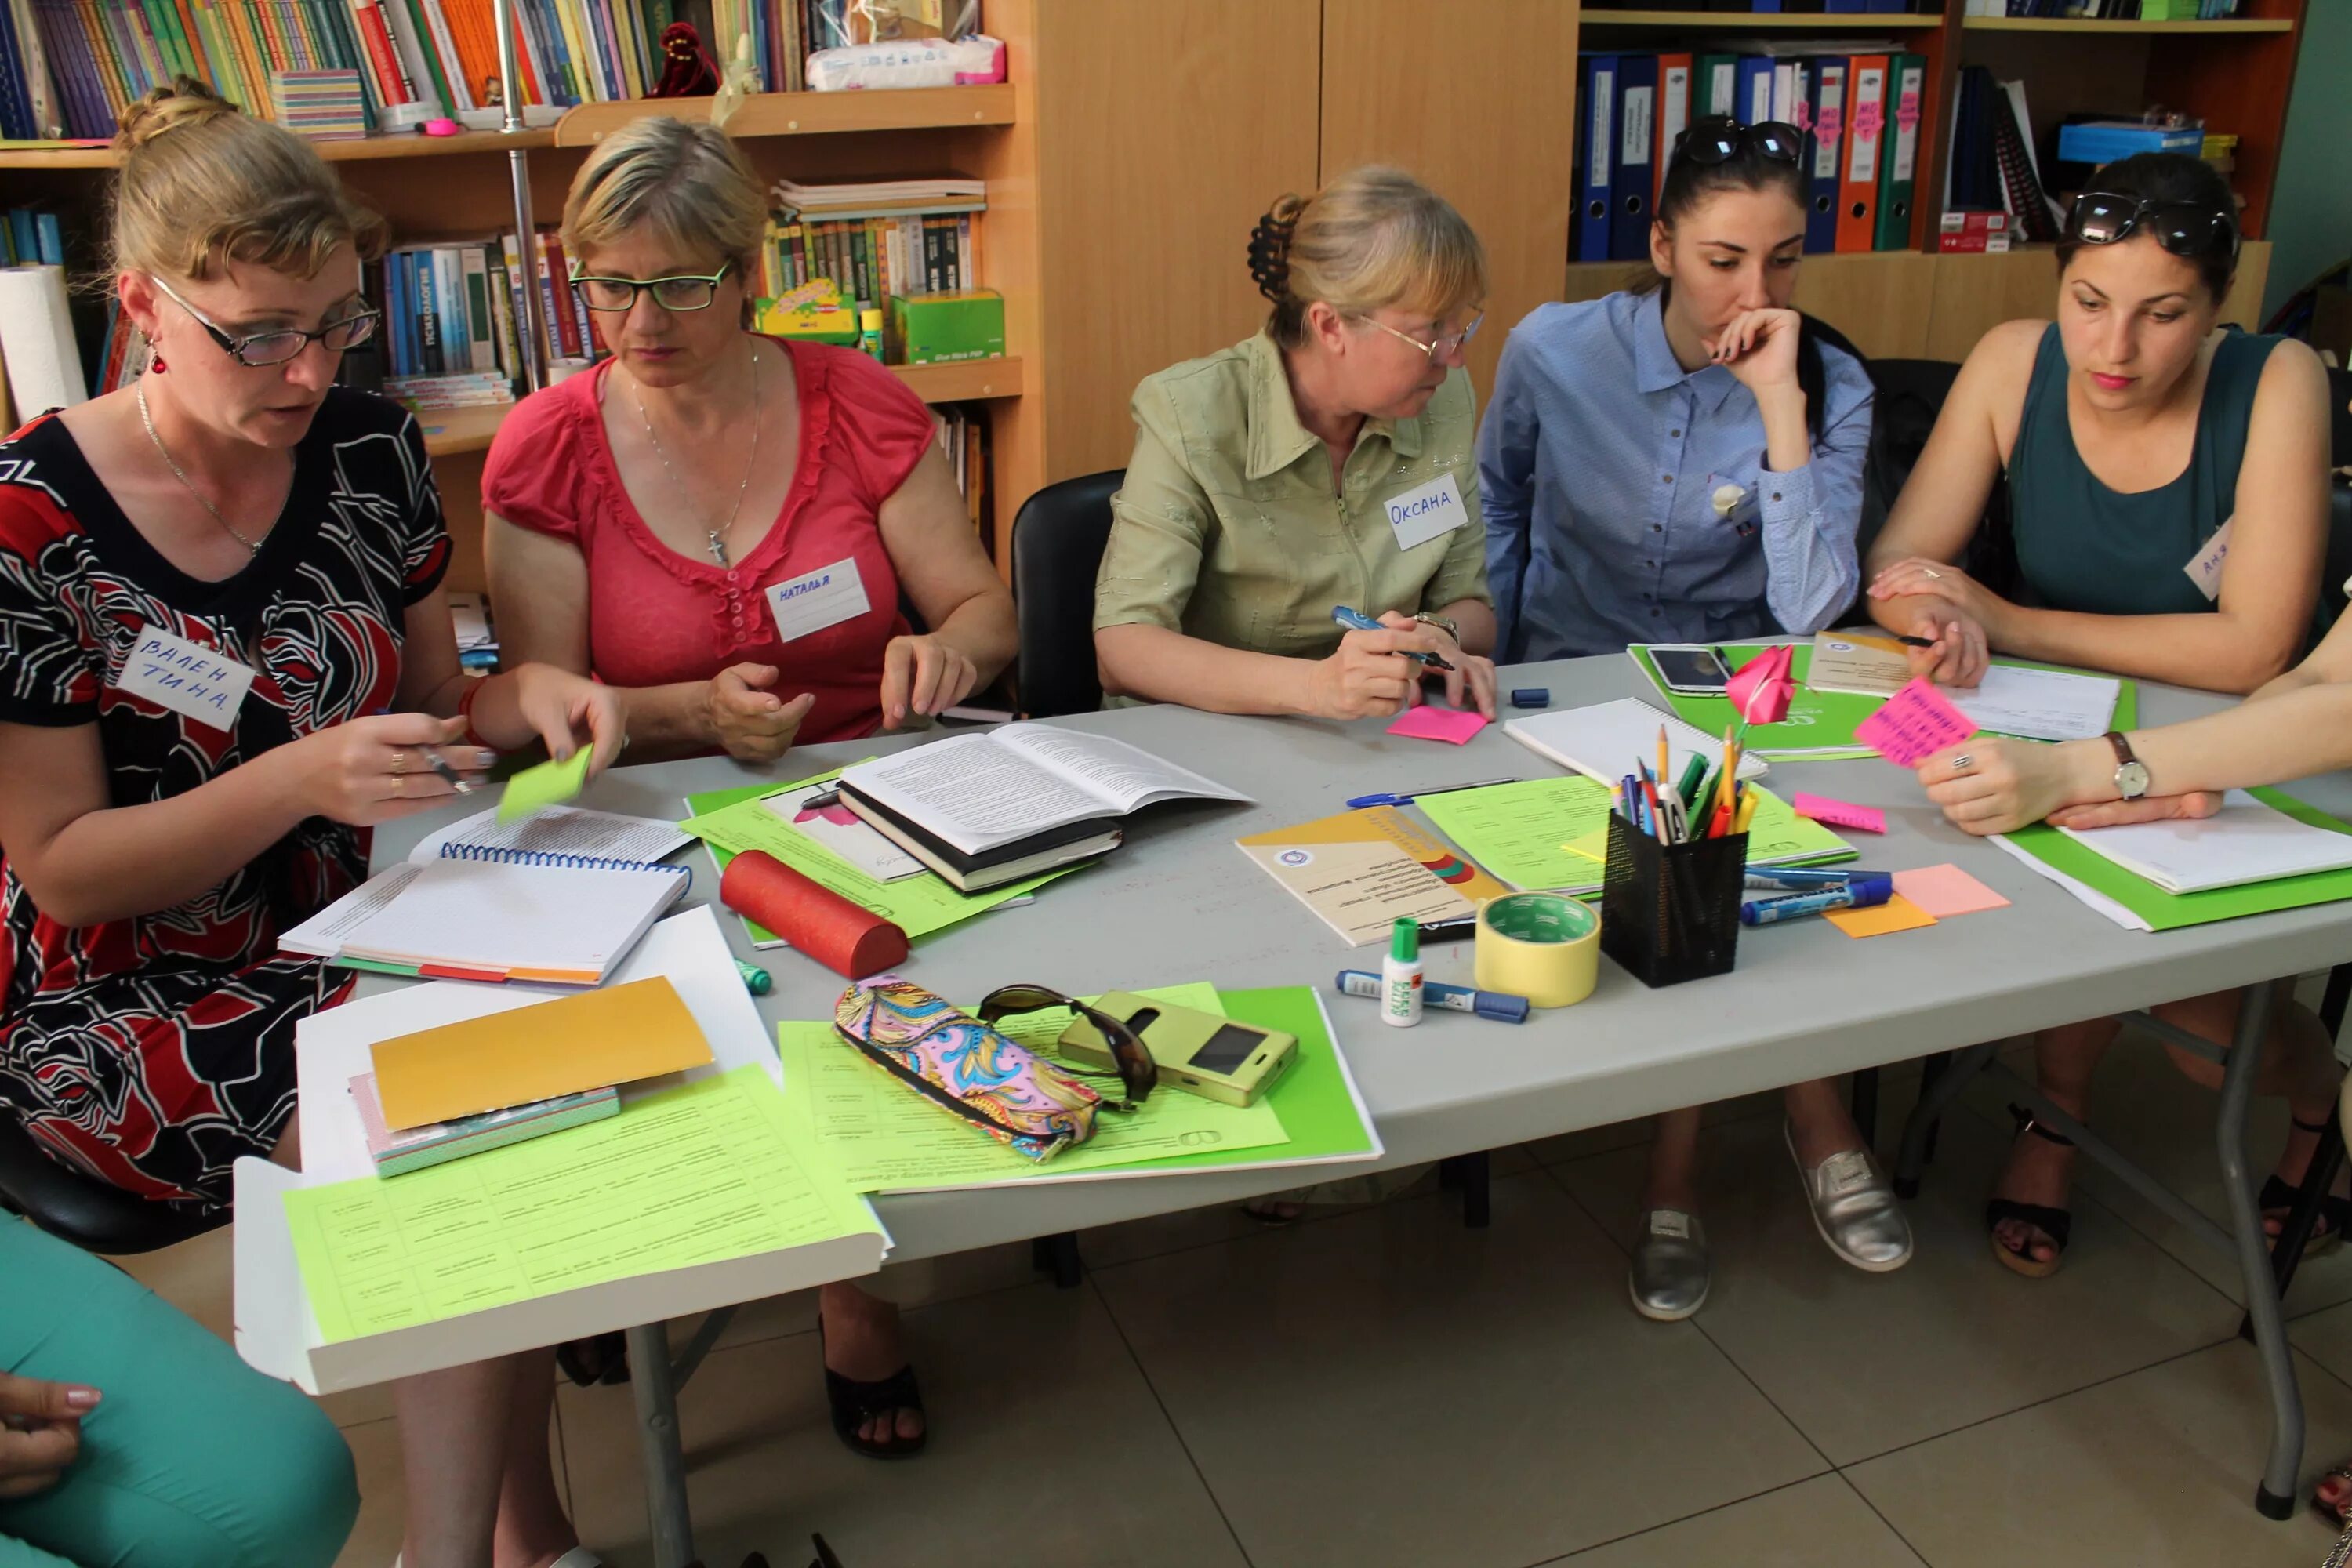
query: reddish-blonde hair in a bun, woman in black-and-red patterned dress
[{"left": 103, "top": 78, "right": 386, "bottom": 287}]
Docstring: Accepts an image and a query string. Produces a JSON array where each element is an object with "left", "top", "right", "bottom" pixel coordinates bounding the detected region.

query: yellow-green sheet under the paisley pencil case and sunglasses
[{"left": 776, "top": 985, "right": 1289, "bottom": 1192}]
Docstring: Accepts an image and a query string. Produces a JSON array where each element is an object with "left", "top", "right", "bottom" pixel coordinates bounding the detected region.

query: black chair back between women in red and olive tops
[{"left": 1014, "top": 468, "right": 1127, "bottom": 720}]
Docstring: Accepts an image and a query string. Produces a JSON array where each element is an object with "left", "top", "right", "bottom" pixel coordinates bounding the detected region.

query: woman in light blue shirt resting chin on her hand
[{"left": 1477, "top": 115, "right": 1912, "bottom": 1321}]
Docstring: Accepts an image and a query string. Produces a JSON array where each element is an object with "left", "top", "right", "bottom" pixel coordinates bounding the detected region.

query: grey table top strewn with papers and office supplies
[{"left": 367, "top": 656, "right": 2352, "bottom": 1258}]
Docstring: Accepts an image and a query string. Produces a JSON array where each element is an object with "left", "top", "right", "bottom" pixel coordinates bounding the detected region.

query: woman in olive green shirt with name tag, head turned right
[{"left": 1094, "top": 169, "right": 1494, "bottom": 720}]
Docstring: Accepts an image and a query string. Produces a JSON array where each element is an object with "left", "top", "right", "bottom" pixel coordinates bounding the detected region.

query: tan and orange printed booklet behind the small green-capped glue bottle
[{"left": 1237, "top": 794, "right": 1510, "bottom": 947}]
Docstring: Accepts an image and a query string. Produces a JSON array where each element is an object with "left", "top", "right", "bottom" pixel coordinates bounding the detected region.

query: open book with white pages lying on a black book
[{"left": 842, "top": 724, "right": 1249, "bottom": 855}]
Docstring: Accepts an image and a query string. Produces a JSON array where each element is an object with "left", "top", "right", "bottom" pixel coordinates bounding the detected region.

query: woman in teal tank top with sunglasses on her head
[{"left": 1865, "top": 153, "right": 2352, "bottom": 1276}]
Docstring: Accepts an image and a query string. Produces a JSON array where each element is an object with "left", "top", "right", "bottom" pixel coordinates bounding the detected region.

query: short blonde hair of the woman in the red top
[{"left": 564, "top": 115, "right": 767, "bottom": 272}]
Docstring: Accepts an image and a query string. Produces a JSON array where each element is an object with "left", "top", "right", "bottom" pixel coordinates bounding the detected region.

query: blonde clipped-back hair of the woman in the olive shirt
[{"left": 1249, "top": 167, "right": 1486, "bottom": 348}]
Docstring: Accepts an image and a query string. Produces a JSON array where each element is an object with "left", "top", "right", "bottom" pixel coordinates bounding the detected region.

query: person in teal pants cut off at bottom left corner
[{"left": 0, "top": 1215, "right": 360, "bottom": 1568}]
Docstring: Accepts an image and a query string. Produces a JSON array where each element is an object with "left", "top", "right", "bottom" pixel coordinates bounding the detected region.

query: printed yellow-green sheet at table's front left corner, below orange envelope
[{"left": 285, "top": 1067, "right": 875, "bottom": 1342}]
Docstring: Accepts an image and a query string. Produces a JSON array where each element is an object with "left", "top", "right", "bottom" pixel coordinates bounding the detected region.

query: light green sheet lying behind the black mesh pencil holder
[{"left": 1414, "top": 774, "right": 1856, "bottom": 893}]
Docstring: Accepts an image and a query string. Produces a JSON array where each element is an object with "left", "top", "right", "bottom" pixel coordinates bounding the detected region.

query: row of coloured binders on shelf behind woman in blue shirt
[{"left": 1569, "top": 45, "right": 1926, "bottom": 261}]
